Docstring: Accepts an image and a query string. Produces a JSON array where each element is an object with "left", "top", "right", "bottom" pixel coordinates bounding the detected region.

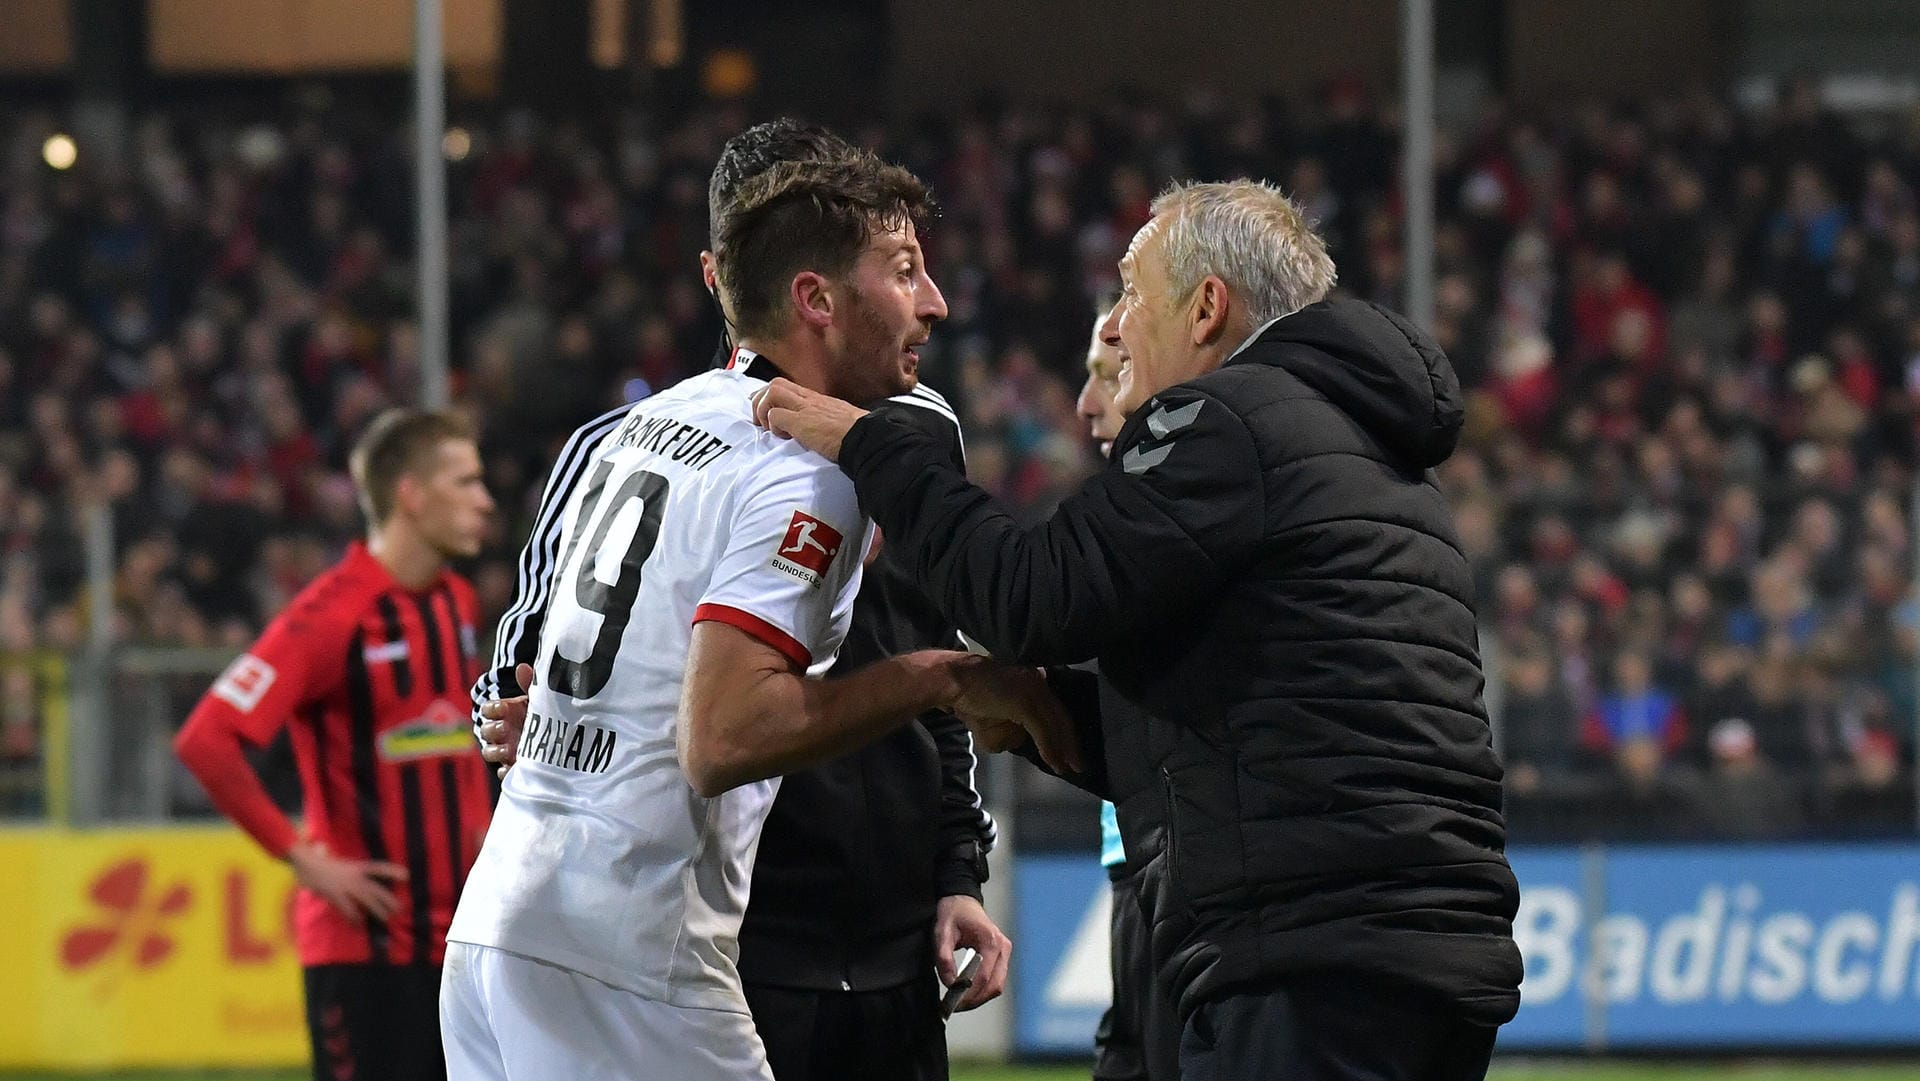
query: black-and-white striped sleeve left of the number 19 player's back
[{"left": 470, "top": 405, "right": 632, "bottom": 730}]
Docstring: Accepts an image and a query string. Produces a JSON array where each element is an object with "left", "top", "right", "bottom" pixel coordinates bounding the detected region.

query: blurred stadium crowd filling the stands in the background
[{"left": 0, "top": 79, "right": 1920, "bottom": 839}]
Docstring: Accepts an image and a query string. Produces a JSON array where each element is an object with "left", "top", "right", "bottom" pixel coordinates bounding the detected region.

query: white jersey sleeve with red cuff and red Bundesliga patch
[{"left": 693, "top": 455, "right": 872, "bottom": 668}]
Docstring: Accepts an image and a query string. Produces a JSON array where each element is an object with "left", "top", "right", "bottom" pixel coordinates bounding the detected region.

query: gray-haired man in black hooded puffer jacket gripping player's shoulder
[{"left": 758, "top": 182, "right": 1521, "bottom": 1081}]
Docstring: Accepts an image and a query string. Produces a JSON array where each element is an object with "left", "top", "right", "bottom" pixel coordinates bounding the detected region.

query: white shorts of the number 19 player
[{"left": 440, "top": 943, "right": 774, "bottom": 1081}]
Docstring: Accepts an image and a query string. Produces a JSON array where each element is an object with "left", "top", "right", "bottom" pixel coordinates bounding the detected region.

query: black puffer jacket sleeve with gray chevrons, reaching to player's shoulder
[{"left": 841, "top": 388, "right": 1265, "bottom": 664}]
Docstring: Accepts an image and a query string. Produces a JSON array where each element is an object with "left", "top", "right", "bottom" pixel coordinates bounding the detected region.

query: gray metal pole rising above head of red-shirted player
[{"left": 413, "top": 0, "right": 447, "bottom": 409}]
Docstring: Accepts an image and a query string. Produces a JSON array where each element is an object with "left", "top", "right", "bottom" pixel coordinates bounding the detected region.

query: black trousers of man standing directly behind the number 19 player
[{"left": 747, "top": 972, "right": 947, "bottom": 1081}]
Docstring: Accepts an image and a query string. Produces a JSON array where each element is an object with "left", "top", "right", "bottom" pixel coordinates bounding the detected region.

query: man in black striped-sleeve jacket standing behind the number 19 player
[{"left": 474, "top": 121, "right": 1012, "bottom": 1081}]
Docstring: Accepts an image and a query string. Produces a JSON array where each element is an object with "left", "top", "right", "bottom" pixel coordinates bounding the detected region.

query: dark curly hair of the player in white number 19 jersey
[{"left": 714, "top": 150, "right": 931, "bottom": 336}]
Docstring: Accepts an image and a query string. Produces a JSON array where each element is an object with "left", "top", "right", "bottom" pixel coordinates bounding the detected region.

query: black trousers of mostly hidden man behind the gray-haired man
[{"left": 1092, "top": 868, "right": 1181, "bottom": 1081}]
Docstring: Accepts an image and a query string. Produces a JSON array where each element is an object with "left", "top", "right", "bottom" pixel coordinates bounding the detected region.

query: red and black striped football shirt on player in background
[{"left": 177, "top": 541, "right": 493, "bottom": 966}]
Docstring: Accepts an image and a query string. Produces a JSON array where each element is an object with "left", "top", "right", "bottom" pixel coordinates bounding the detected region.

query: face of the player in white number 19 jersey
[{"left": 829, "top": 221, "right": 947, "bottom": 403}]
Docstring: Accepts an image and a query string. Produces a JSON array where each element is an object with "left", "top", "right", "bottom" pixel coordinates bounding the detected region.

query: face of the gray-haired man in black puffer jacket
[{"left": 1100, "top": 217, "right": 1194, "bottom": 417}]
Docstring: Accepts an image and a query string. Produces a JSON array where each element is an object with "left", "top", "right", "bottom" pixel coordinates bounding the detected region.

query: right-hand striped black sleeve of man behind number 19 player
[{"left": 870, "top": 388, "right": 996, "bottom": 901}]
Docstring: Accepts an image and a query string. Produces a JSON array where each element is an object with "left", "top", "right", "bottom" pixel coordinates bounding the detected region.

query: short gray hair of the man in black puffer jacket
[{"left": 1152, "top": 180, "right": 1334, "bottom": 326}]
